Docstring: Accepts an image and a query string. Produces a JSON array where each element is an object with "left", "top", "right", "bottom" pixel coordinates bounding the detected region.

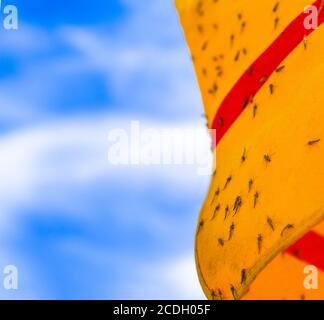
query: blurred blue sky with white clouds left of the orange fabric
[{"left": 0, "top": 0, "right": 209, "bottom": 299}]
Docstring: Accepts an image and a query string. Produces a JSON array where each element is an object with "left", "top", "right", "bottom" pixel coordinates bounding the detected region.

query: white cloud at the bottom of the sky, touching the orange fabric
[{"left": 58, "top": 239, "right": 206, "bottom": 300}]
